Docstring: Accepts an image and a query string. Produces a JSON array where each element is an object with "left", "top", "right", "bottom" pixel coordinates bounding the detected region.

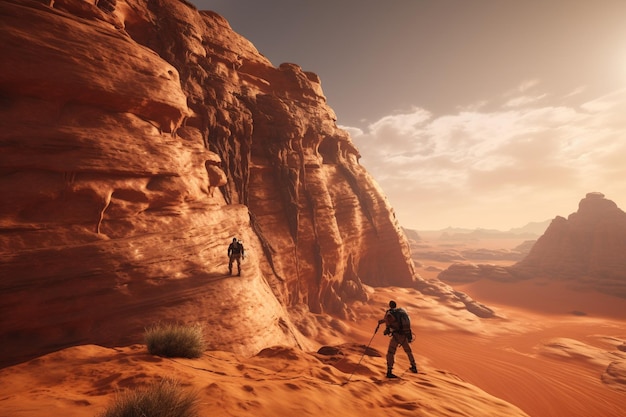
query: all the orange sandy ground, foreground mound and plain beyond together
[{"left": 0, "top": 236, "right": 626, "bottom": 417}]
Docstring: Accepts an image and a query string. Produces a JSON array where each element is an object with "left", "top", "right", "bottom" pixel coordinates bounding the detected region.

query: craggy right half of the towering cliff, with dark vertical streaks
[{"left": 120, "top": 1, "right": 415, "bottom": 308}]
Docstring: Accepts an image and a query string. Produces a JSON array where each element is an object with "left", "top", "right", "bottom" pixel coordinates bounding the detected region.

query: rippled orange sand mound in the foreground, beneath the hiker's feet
[{"left": 0, "top": 344, "right": 525, "bottom": 417}]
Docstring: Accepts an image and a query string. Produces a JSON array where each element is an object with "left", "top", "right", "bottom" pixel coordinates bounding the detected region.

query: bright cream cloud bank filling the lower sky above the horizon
[{"left": 344, "top": 85, "right": 626, "bottom": 229}]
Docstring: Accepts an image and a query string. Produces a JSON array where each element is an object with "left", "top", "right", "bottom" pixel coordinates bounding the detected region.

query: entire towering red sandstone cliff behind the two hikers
[{"left": 0, "top": 0, "right": 431, "bottom": 363}]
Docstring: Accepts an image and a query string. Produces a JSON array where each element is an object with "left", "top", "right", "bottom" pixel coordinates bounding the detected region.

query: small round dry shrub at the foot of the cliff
[{"left": 145, "top": 324, "right": 205, "bottom": 358}]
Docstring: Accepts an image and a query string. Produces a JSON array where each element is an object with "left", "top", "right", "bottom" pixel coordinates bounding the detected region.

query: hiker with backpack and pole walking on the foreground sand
[{"left": 378, "top": 300, "right": 417, "bottom": 378}]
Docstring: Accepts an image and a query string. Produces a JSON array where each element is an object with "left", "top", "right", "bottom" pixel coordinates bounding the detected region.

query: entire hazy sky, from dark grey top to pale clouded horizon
[{"left": 192, "top": 0, "right": 626, "bottom": 230}]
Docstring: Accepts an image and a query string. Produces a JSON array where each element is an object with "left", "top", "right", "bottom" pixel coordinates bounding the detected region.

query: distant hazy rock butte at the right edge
[{"left": 512, "top": 192, "right": 626, "bottom": 297}]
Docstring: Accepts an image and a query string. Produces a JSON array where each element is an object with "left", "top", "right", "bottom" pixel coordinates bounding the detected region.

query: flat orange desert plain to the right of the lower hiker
[{"left": 400, "top": 239, "right": 626, "bottom": 417}]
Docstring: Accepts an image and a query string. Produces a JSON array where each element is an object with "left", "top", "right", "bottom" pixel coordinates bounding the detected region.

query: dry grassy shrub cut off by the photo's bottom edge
[{"left": 99, "top": 379, "right": 199, "bottom": 417}]
